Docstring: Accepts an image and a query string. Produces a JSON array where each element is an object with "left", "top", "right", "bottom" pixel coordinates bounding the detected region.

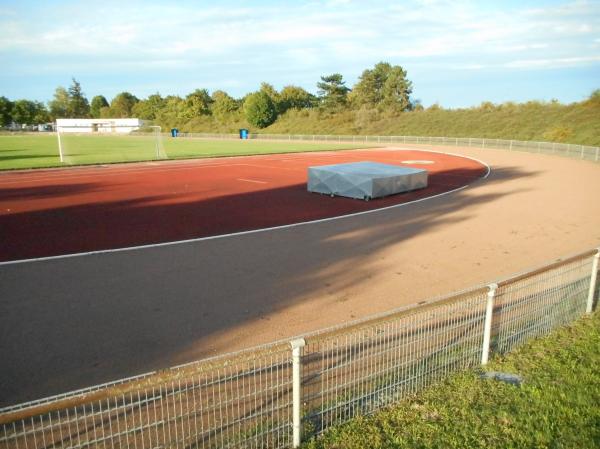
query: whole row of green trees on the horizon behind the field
[{"left": 0, "top": 62, "right": 412, "bottom": 128}]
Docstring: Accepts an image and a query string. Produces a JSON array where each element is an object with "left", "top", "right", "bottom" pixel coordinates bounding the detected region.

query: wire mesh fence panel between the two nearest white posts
[{"left": 303, "top": 289, "right": 486, "bottom": 434}]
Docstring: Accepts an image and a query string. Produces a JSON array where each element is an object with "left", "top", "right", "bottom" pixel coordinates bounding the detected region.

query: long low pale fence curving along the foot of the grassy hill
[{"left": 173, "top": 133, "right": 600, "bottom": 162}]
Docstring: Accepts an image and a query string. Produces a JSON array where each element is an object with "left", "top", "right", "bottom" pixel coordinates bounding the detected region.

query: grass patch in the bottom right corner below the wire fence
[{"left": 305, "top": 313, "right": 600, "bottom": 449}]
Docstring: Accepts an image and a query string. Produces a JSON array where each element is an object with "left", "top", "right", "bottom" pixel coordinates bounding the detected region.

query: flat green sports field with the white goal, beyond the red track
[{"left": 0, "top": 134, "right": 364, "bottom": 170}]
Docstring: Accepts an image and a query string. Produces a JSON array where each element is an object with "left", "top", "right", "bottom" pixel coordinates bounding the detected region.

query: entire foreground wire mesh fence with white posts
[{"left": 0, "top": 250, "right": 600, "bottom": 449}]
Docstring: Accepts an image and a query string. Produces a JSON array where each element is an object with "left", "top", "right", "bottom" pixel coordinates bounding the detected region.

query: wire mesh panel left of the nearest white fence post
[{"left": 0, "top": 346, "right": 291, "bottom": 449}]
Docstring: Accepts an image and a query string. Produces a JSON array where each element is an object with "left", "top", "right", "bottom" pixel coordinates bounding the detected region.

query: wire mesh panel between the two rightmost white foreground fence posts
[{"left": 492, "top": 255, "right": 592, "bottom": 353}]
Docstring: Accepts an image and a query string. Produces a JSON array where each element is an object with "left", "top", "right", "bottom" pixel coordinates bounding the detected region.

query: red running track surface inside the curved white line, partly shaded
[{"left": 0, "top": 149, "right": 487, "bottom": 261}]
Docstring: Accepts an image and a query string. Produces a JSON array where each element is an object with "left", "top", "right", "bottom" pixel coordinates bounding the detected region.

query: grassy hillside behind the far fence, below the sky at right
[{"left": 181, "top": 91, "right": 600, "bottom": 146}]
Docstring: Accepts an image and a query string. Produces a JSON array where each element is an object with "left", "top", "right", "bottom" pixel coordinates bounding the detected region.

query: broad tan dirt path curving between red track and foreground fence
[{"left": 0, "top": 146, "right": 600, "bottom": 404}]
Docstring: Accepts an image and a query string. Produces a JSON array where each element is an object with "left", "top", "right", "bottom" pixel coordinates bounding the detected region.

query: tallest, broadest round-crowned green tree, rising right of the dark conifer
[{"left": 349, "top": 62, "right": 412, "bottom": 111}]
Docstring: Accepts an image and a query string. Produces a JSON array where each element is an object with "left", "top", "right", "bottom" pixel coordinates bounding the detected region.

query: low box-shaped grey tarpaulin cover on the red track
[{"left": 308, "top": 161, "right": 427, "bottom": 199}]
